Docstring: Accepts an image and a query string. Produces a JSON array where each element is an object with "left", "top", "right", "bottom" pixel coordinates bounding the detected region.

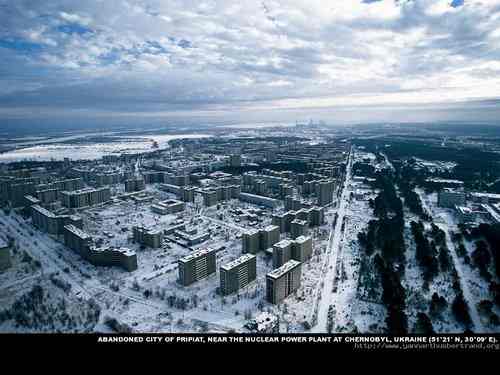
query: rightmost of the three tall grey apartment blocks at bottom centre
[{"left": 266, "top": 260, "right": 302, "bottom": 304}]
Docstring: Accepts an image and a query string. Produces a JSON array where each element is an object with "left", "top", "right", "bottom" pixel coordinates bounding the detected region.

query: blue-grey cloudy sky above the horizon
[{"left": 0, "top": 0, "right": 500, "bottom": 128}]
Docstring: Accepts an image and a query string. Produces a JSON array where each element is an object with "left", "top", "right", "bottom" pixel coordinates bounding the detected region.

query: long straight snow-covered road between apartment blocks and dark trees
[{"left": 312, "top": 149, "right": 353, "bottom": 333}]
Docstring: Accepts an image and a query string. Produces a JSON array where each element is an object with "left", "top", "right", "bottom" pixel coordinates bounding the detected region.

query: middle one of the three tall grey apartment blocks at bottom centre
[{"left": 220, "top": 254, "right": 257, "bottom": 296}]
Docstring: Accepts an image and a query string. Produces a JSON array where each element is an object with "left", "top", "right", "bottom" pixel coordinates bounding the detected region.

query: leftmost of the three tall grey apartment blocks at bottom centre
[{"left": 179, "top": 249, "right": 216, "bottom": 286}]
